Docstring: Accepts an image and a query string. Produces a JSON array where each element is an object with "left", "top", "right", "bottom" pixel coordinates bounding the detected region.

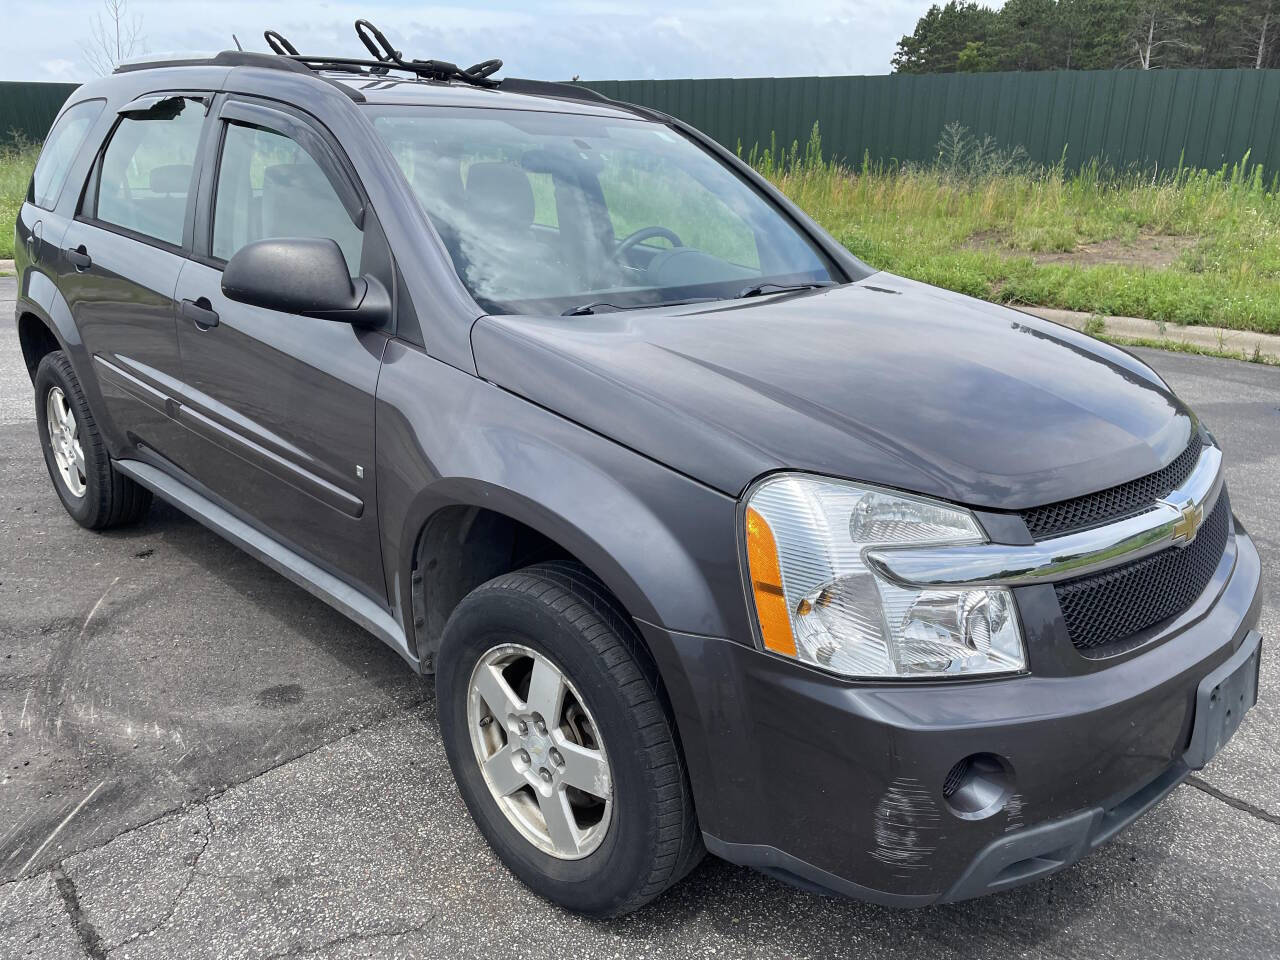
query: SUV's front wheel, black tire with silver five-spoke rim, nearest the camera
[{"left": 435, "top": 563, "right": 705, "bottom": 916}]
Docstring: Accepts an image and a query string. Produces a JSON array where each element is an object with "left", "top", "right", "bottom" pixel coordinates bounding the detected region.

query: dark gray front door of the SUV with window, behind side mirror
[{"left": 175, "top": 97, "right": 394, "bottom": 600}]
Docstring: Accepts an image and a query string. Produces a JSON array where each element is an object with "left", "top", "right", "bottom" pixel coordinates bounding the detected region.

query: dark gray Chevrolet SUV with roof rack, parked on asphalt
[{"left": 17, "top": 31, "right": 1261, "bottom": 915}]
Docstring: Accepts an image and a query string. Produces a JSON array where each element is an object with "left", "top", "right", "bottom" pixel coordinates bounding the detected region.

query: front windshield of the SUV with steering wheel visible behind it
[{"left": 367, "top": 106, "right": 835, "bottom": 314}]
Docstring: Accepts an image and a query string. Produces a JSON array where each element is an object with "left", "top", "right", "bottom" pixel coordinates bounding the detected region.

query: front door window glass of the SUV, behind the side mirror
[{"left": 212, "top": 123, "right": 364, "bottom": 275}]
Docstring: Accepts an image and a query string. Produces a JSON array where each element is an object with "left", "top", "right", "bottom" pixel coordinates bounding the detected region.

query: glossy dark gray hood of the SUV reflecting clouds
[{"left": 472, "top": 273, "right": 1194, "bottom": 509}]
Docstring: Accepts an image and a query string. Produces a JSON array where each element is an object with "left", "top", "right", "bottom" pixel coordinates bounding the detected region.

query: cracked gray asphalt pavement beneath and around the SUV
[{"left": 0, "top": 278, "right": 1280, "bottom": 960}]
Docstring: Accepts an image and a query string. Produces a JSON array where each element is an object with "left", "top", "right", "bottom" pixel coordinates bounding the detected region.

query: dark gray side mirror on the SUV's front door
[{"left": 223, "top": 237, "right": 392, "bottom": 326}]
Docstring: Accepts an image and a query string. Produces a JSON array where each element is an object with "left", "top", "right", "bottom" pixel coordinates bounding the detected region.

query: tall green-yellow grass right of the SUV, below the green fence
[{"left": 748, "top": 127, "right": 1280, "bottom": 333}]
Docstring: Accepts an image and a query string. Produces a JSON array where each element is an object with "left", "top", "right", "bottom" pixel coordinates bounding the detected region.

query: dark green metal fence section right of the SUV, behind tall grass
[{"left": 585, "top": 70, "right": 1280, "bottom": 169}]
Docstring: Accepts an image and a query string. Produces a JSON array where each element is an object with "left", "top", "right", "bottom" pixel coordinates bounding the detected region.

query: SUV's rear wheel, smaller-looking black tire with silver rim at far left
[{"left": 36, "top": 351, "right": 151, "bottom": 530}]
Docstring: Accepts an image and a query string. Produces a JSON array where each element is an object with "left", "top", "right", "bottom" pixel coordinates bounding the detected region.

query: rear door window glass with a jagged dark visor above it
[{"left": 96, "top": 97, "right": 205, "bottom": 246}]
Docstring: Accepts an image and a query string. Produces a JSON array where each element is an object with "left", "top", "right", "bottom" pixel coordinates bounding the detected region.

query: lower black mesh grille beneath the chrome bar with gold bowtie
[{"left": 1056, "top": 486, "right": 1231, "bottom": 657}]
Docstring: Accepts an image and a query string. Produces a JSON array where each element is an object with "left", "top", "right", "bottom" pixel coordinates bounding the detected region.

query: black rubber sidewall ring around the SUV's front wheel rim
[{"left": 436, "top": 591, "right": 657, "bottom": 914}]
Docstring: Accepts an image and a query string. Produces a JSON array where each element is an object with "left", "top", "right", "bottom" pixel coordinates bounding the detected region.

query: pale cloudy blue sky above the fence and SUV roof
[{"left": 0, "top": 0, "right": 998, "bottom": 82}]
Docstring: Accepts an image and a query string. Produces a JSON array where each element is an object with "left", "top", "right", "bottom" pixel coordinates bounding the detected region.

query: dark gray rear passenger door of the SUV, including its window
[{"left": 59, "top": 93, "right": 210, "bottom": 456}]
